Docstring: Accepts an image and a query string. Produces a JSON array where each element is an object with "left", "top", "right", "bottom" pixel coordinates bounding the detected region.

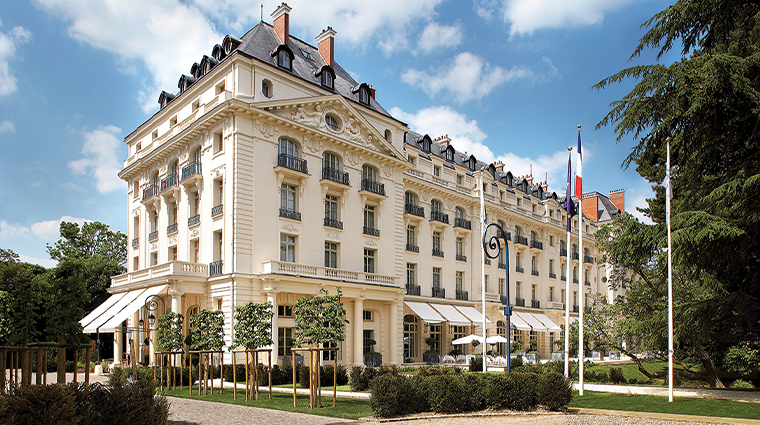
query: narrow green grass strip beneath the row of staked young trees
[{"left": 163, "top": 386, "right": 372, "bottom": 420}]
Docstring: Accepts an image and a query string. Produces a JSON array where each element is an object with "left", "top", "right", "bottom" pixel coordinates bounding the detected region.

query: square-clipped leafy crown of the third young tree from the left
[{"left": 229, "top": 302, "right": 273, "bottom": 351}]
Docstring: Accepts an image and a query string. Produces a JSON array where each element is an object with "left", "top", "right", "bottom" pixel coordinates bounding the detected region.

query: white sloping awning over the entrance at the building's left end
[{"left": 79, "top": 285, "right": 168, "bottom": 333}]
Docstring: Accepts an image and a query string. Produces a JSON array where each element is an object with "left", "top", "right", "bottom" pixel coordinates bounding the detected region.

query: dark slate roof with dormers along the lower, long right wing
[{"left": 404, "top": 130, "right": 558, "bottom": 200}]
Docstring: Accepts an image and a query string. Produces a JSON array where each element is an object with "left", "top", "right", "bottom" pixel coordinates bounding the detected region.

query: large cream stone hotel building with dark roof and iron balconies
[{"left": 82, "top": 3, "right": 605, "bottom": 365}]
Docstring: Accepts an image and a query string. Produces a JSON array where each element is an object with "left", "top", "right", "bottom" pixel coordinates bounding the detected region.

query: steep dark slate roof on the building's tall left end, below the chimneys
[{"left": 157, "top": 22, "right": 395, "bottom": 119}]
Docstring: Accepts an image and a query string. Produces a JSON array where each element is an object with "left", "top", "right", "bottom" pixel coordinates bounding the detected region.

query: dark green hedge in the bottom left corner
[{"left": 0, "top": 380, "right": 169, "bottom": 425}]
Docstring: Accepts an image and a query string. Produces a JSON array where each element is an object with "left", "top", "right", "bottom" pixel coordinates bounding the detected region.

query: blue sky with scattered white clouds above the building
[{"left": 0, "top": 0, "right": 678, "bottom": 267}]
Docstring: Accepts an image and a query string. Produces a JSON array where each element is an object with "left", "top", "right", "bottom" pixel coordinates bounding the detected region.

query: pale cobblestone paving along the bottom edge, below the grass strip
[{"left": 167, "top": 397, "right": 351, "bottom": 425}]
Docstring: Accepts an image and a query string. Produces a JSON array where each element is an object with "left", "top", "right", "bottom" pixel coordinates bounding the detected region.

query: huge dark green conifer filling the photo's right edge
[{"left": 596, "top": 0, "right": 760, "bottom": 386}]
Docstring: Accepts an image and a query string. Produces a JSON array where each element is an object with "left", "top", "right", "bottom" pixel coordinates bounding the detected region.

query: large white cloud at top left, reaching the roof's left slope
[{"left": 36, "top": 0, "right": 223, "bottom": 112}]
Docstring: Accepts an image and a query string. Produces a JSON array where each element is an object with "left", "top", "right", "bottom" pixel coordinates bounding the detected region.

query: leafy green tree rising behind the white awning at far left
[{"left": 47, "top": 221, "right": 127, "bottom": 311}]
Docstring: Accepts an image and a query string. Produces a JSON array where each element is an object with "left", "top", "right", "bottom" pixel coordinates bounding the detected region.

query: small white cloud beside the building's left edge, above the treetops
[{"left": 69, "top": 125, "right": 124, "bottom": 193}]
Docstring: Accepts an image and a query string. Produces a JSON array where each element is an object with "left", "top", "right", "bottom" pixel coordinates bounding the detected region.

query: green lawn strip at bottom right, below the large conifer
[{"left": 568, "top": 391, "right": 760, "bottom": 419}]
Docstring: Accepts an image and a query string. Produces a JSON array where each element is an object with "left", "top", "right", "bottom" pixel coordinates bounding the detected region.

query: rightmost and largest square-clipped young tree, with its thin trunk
[{"left": 293, "top": 288, "right": 346, "bottom": 408}]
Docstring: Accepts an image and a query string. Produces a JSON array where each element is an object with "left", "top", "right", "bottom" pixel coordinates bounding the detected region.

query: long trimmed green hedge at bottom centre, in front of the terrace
[{"left": 365, "top": 368, "right": 572, "bottom": 417}]
